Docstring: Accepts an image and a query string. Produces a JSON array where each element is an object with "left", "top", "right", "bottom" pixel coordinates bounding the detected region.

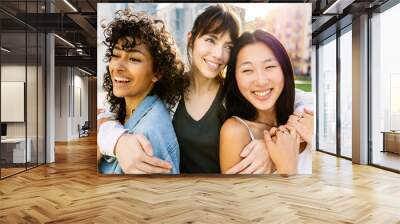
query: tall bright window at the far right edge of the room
[{"left": 370, "top": 4, "right": 400, "bottom": 170}]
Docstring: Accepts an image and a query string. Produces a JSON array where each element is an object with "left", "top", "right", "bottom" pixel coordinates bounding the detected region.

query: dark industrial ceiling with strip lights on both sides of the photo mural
[{"left": 0, "top": 0, "right": 387, "bottom": 74}]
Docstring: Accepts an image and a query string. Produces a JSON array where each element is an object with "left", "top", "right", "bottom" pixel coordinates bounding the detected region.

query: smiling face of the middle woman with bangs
[{"left": 192, "top": 32, "right": 233, "bottom": 79}]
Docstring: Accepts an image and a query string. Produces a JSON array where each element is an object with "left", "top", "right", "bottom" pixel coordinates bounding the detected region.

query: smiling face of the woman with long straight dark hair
[{"left": 235, "top": 42, "right": 284, "bottom": 111}]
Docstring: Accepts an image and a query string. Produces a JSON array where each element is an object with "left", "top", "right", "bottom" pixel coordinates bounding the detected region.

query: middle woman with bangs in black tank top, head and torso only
[{"left": 173, "top": 5, "right": 239, "bottom": 173}]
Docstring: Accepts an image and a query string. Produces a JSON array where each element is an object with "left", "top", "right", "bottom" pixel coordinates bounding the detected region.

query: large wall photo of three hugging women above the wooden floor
[{"left": 97, "top": 3, "right": 314, "bottom": 175}]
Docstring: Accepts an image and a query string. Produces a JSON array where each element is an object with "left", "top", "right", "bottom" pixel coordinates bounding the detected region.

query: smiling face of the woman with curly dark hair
[{"left": 109, "top": 39, "right": 157, "bottom": 98}]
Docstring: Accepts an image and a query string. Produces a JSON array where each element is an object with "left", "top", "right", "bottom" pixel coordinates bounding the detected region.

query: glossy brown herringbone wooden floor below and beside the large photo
[{"left": 0, "top": 137, "right": 400, "bottom": 224}]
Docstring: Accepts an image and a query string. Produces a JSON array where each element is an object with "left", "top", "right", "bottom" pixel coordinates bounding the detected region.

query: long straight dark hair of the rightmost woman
[{"left": 222, "top": 30, "right": 295, "bottom": 125}]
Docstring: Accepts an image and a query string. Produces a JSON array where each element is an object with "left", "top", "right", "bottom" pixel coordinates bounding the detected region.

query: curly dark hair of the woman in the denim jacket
[{"left": 103, "top": 9, "right": 189, "bottom": 123}]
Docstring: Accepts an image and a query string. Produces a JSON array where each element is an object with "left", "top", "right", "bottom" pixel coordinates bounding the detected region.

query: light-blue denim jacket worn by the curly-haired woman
[{"left": 98, "top": 96, "right": 179, "bottom": 174}]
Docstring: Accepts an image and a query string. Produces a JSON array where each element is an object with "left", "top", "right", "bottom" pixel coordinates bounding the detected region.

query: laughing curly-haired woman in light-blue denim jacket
[{"left": 98, "top": 9, "right": 188, "bottom": 174}]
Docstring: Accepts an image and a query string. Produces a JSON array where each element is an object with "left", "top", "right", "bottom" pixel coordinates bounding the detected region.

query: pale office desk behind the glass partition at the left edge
[{"left": 1, "top": 138, "right": 32, "bottom": 163}]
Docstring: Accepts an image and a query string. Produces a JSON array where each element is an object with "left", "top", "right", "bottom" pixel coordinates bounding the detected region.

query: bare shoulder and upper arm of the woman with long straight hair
[{"left": 219, "top": 118, "right": 251, "bottom": 173}]
